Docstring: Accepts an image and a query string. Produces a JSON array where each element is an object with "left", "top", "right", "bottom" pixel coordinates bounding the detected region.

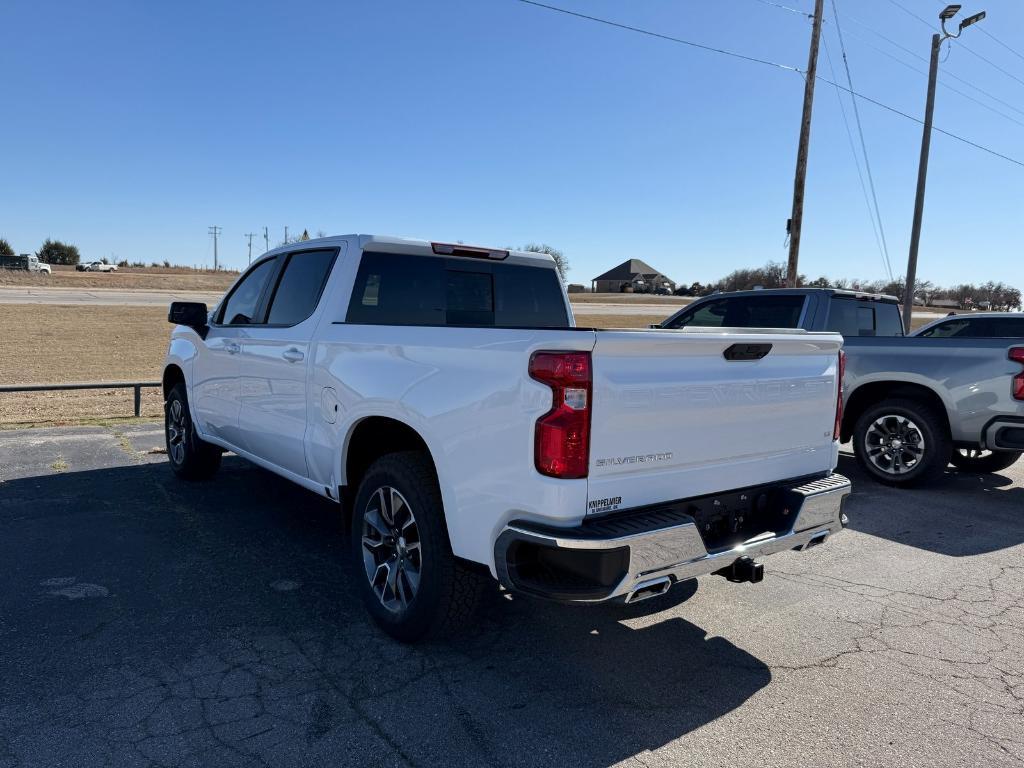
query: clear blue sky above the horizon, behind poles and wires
[{"left": 0, "top": 0, "right": 1024, "bottom": 288}]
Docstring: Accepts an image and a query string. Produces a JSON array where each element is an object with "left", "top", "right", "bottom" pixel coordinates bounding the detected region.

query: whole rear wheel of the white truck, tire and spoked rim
[{"left": 352, "top": 451, "right": 483, "bottom": 643}]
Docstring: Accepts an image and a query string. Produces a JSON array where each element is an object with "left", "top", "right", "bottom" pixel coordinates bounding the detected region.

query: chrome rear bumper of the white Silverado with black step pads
[{"left": 495, "top": 474, "right": 850, "bottom": 602}]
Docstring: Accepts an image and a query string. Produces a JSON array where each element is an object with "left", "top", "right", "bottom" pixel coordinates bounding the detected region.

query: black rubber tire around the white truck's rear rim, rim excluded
[{"left": 351, "top": 451, "right": 484, "bottom": 643}]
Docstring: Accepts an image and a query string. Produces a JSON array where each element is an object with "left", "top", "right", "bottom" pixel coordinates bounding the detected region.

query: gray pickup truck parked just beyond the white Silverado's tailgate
[{"left": 658, "top": 289, "right": 1024, "bottom": 485}]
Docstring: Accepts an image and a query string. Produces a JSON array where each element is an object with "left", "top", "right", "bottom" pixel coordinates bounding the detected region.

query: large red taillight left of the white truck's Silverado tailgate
[{"left": 529, "top": 352, "right": 592, "bottom": 478}]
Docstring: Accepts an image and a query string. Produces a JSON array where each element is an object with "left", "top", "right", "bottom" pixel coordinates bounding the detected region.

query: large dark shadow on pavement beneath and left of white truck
[{"left": 0, "top": 459, "right": 771, "bottom": 768}]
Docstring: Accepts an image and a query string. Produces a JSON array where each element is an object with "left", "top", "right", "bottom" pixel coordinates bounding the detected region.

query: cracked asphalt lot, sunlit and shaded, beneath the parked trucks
[{"left": 0, "top": 425, "right": 1024, "bottom": 768}]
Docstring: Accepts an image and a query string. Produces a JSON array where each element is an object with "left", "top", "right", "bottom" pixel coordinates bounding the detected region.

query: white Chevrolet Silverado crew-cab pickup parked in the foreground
[{"left": 163, "top": 234, "right": 850, "bottom": 641}]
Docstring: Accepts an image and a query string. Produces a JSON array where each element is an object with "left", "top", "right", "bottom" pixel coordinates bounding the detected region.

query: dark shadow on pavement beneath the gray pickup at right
[{"left": 839, "top": 454, "right": 1024, "bottom": 557}]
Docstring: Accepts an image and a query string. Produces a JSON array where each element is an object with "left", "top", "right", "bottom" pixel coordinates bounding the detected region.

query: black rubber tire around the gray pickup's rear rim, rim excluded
[{"left": 853, "top": 398, "right": 952, "bottom": 487}]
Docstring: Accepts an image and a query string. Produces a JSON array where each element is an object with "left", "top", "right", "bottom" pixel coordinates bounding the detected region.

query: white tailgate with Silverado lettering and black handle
[{"left": 587, "top": 330, "right": 842, "bottom": 514}]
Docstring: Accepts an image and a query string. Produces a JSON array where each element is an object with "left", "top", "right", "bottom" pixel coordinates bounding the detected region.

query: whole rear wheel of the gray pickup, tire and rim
[{"left": 853, "top": 399, "right": 952, "bottom": 485}]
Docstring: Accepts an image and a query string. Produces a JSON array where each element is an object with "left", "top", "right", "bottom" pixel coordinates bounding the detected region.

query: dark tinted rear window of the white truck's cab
[{"left": 346, "top": 253, "right": 568, "bottom": 328}]
